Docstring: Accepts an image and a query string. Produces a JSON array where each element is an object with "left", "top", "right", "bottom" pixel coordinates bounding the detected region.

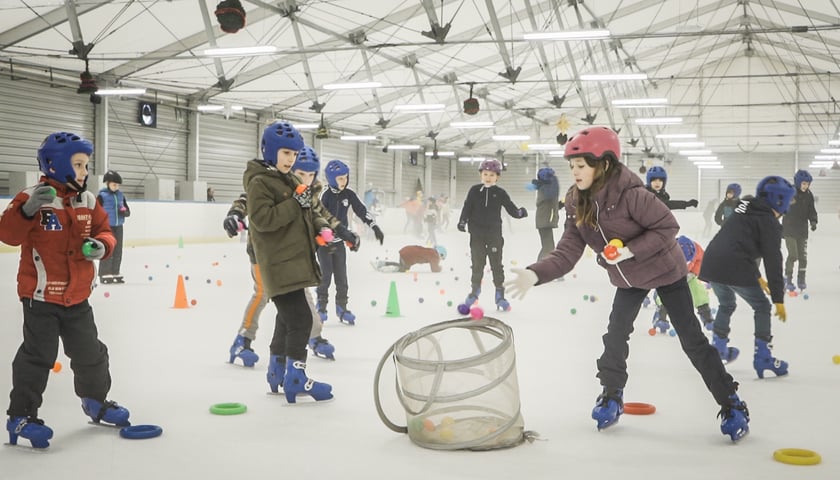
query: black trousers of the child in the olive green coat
[{"left": 269, "top": 290, "right": 312, "bottom": 361}]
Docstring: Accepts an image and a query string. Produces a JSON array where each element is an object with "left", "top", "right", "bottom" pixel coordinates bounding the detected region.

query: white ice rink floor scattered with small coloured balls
[{"left": 0, "top": 213, "right": 840, "bottom": 480}]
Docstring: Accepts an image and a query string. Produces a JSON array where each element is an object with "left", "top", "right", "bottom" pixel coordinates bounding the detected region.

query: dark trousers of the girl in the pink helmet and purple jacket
[{"left": 597, "top": 277, "right": 738, "bottom": 406}]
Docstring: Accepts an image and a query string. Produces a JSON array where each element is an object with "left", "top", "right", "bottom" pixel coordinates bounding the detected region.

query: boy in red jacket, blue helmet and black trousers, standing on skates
[{"left": 0, "top": 132, "right": 129, "bottom": 448}]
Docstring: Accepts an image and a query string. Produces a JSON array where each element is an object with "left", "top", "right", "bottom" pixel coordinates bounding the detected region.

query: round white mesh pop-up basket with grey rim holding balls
[{"left": 374, "top": 317, "right": 534, "bottom": 450}]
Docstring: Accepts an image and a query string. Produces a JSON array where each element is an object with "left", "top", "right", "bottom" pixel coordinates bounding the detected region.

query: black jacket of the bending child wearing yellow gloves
[{"left": 699, "top": 196, "right": 785, "bottom": 303}]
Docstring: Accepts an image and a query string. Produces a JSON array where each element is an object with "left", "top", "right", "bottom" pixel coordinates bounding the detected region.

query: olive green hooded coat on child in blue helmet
[{"left": 242, "top": 160, "right": 330, "bottom": 297}]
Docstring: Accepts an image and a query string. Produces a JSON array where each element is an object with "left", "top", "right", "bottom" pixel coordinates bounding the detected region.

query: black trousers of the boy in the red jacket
[{"left": 6, "top": 298, "right": 111, "bottom": 417}]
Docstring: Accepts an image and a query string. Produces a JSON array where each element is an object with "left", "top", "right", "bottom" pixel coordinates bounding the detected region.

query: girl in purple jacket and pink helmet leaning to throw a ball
[{"left": 506, "top": 127, "right": 750, "bottom": 441}]
